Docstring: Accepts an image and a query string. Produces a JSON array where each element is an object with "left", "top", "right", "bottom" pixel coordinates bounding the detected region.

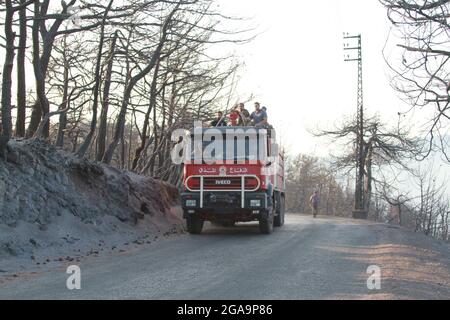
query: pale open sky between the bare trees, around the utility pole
[{"left": 219, "top": 0, "right": 407, "bottom": 157}]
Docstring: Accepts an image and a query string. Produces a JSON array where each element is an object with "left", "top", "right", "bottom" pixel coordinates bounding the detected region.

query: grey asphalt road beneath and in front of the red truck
[{"left": 0, "top": 215, "right": 450, "bottom": 300}]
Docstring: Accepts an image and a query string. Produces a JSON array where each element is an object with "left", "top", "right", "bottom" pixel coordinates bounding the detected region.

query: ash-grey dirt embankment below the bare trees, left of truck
[{"left": 0, "top": 141, "right": 182, "bottom": 270}]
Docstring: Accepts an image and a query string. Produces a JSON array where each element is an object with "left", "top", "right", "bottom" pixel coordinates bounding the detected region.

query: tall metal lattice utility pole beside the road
[{"left": 344, "top": 33, "right": 367, "bottom": 219}]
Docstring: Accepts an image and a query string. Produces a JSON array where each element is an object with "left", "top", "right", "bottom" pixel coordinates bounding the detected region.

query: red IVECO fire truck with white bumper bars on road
[{"left": 181, "top": 127, "right": 285, "bottom": 234}]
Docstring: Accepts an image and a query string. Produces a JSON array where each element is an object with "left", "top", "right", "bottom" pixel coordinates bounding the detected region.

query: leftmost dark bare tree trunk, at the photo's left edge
[{"left": 0, "top": 0, "right": 15, "bottom": 156}]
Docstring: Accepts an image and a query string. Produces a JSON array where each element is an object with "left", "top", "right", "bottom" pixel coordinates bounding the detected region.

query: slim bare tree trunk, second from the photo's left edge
[{"left": 16, "top": 0, "right": 27, "bottom": 137}]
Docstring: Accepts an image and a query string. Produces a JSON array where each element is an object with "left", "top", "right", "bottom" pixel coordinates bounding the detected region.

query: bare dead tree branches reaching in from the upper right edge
[{"left": 380, "top": 0, "right": 450, "bottom": 162}]
